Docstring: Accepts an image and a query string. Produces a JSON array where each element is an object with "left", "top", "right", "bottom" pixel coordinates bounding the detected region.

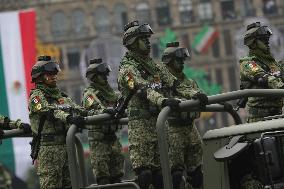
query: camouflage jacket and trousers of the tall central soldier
[{"left": 118, "top": 51, "right": 175, "bottom": 169}]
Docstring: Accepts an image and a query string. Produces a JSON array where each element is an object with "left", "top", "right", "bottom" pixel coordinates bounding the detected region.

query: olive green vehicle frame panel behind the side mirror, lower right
[{"left": 203, "top": 119, "right": 284, "bottom": 189}]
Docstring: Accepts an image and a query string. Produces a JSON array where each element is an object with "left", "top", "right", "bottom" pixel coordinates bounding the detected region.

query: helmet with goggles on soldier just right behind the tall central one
[{"left": 162, "top": 42, "right": 190, "bottom": 64}]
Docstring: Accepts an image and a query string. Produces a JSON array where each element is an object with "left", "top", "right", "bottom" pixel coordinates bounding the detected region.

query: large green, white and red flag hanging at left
[{"left": 0, "top": 10, "right": 36, "bottom": 178}]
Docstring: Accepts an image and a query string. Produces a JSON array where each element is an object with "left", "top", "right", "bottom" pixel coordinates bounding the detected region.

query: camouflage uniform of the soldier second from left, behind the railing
[{"left": 82, "top": 83, "right": 124, "bottom": 183}]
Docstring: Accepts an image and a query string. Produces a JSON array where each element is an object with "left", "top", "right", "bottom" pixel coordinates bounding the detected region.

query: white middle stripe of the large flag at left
[{"left": 0, "top": 12, "right": 31, "bottom": 178}]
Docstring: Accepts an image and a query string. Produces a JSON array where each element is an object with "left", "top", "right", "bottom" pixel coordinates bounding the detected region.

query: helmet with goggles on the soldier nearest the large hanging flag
[{"left": 31, "top": 56, "right": 60, "bottom": 82}]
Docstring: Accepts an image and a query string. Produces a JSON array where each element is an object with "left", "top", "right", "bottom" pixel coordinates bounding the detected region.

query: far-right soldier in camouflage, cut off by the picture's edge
[{"left": 240, "top": 22, "right": 284, "bottom": 122}]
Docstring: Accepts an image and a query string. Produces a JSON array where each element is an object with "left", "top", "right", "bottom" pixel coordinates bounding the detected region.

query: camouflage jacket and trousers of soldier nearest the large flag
[{"left": 29, "top": 84, "right": 84, "bottom": 189}]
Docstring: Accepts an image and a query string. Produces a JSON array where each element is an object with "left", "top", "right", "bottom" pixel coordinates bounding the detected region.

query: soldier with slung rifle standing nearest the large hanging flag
[{"left": 29, "top": 56, "right": 85, "bottom": 189}]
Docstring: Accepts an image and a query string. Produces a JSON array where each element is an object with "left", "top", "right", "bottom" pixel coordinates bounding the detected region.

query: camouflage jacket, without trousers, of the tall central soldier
[{"left": 118, "top": 51, "right": 176, "bottom": 117}]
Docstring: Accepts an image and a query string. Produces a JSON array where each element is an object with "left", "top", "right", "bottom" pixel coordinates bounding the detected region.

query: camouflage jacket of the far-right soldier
[{"left": 240, "top": 55, "right": 284, "bottom": 108}]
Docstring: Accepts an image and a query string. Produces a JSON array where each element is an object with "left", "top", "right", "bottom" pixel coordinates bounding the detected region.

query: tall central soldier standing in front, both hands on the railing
[{"left": 118, "top": 21, "right": 180, "bottom": 189}]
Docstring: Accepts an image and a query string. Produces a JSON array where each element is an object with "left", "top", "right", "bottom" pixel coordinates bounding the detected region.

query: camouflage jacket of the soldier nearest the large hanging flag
[{"left": 29, "top": 85, "right": 84, "bottom": 135}]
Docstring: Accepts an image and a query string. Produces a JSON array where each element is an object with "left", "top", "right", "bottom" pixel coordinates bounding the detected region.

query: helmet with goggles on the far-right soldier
[{"left": 244, "top": 22, "right": 272, "bottom": 46}]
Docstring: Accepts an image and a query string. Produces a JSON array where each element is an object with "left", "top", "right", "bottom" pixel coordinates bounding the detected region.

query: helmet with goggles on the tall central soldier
[{"left": 123, "top": 20, "right": 153, "bottom": 46}]
